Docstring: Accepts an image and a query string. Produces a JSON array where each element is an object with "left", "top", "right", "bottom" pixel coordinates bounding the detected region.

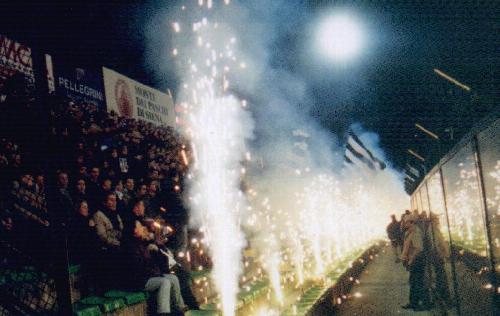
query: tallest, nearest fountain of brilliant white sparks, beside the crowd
[{"left": 176, "top": 0, "right": 251, "bottom": 316}]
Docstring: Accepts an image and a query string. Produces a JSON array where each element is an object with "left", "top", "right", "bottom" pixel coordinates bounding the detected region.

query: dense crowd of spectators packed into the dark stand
[{"left": 0, "top": 76, "right": 196, "bottom": 312}]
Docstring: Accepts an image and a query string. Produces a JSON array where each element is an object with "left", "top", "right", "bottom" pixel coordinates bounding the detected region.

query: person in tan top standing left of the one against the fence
[{"left": 401, "top": 214, "right": 429, "bottom": 310}]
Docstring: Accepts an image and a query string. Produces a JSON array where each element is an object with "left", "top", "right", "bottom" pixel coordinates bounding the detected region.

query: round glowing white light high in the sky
[{"left": 317, "top": 14, "right": 363, "bottom": 61}]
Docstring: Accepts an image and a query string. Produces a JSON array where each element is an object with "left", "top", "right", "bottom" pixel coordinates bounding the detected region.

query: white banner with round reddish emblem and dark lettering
[{"left": 102, "top": 67, "right": 175, "bottom": 127}]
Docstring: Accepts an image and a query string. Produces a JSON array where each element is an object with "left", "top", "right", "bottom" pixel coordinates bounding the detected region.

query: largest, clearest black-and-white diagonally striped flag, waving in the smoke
[{"left": 344, "top": 130, "right": 386, "bottom": 170}]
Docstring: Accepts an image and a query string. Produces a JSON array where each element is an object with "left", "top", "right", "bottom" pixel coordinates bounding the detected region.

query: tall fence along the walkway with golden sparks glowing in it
[{"left": 411, "top": 111, "right": 500, "bottom": 315}]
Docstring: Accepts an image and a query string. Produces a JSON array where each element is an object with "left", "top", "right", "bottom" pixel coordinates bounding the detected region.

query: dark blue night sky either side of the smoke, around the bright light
[{"left": 0, "top": 0, "right": 500, "bottom": 190}]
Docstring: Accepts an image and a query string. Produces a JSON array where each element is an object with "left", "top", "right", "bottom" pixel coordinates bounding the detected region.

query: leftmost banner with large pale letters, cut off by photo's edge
[{"left": 0, "top": 34, "right": 35, "bottom": 89}]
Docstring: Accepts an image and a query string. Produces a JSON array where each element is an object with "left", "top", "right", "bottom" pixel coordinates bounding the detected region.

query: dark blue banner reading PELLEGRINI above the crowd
[{"left": 45, "top": 55, "right": 105, "bottom": 109}]
